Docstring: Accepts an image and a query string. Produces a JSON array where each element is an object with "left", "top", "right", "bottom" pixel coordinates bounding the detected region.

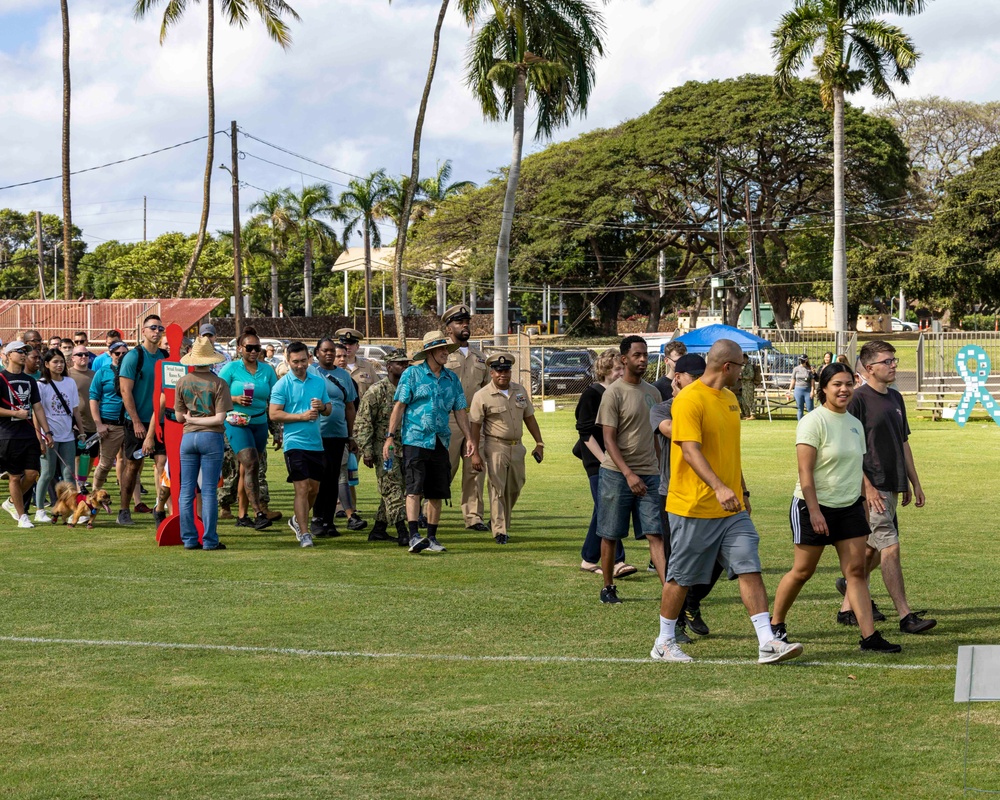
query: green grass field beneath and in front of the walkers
[{"left": 0, "top": 408, "right": 1000, "bottom": 800}]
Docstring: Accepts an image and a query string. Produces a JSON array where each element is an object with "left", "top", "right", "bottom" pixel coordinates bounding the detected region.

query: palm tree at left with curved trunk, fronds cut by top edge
[{"left": 132, "top": 0, "right": 299, "bottom": 297}]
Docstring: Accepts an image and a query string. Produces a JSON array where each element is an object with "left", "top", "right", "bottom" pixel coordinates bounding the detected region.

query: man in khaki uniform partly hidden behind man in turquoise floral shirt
[{"left": 441, "top": 304, "right": 490, "bottom": 532}]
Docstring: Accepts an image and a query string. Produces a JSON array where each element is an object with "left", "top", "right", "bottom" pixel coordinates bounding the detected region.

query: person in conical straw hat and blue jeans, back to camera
[{"left": 174, "top": 336, "right": 233, "bottom": 550}]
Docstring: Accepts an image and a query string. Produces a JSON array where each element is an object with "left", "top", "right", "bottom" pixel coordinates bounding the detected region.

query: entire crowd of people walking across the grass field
[{"left": 0, "top": 318, "right": 936, "bottom": 663}]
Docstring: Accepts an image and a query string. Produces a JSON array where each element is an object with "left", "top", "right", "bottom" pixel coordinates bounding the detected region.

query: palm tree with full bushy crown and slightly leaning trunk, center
[{"left": 459, "top": 0, "right": 604, "bottom": 345}]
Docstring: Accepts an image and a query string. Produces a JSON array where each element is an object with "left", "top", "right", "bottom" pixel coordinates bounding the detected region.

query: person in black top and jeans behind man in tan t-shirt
[{"left": 573, "top": 347, "right": 636, "bottom": 578}]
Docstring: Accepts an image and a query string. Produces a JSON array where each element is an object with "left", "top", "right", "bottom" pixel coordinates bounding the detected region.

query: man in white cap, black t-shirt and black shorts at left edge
[{"left": 0, "top": 342, "right": 52, "bottom": 528}]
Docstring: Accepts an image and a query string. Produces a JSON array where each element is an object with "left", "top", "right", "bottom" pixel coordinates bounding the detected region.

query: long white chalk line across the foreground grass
[{"left": 0, "top": 636, "right": 955, "bottom": 671}]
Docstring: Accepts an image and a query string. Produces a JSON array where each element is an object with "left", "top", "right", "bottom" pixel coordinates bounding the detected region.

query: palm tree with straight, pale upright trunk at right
[{"left": 771, "top": 0, "right": 925, "bottom": 340}]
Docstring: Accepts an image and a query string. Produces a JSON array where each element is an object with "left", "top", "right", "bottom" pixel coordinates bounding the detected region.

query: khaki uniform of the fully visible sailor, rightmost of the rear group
[{"left": 469, "top": 381, "right": 535, "bottom": 536}]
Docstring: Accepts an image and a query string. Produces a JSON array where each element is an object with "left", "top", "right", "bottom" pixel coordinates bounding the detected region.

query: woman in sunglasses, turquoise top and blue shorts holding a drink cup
[{"left": 219, "top": 327, "right": 278, "bottom": 530}]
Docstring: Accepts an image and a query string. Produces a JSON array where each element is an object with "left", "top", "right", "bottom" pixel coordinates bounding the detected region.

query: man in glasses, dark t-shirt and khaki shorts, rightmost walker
[{"left": 837, "top": 341, "right": 937, "bottom": 633}]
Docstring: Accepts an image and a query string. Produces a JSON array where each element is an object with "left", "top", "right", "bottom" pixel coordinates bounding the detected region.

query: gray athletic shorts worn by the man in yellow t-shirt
[{"left": 667, "top": 511, "right": 760, "bottom": 586}]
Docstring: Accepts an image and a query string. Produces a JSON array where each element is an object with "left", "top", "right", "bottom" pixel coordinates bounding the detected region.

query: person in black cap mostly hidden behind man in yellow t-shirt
[{"left": 649, "top": 353, "right": 722, "bottom": 644}]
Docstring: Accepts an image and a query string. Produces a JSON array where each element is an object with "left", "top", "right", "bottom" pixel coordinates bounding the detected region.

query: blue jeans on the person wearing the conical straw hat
[{"left": 179, "top": 431, "right": 225, "bottom": 550}]
